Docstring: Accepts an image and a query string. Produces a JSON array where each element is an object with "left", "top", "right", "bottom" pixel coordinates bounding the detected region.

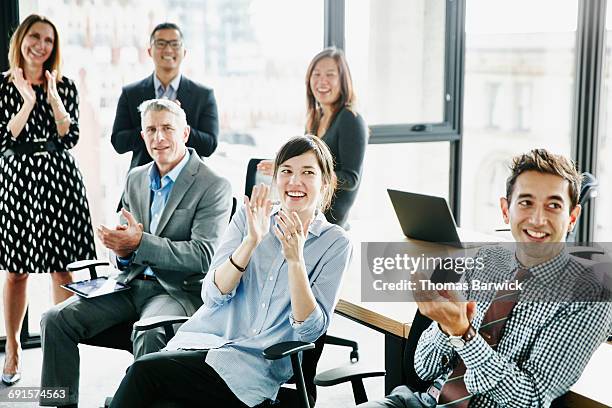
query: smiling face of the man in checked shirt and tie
[{"left": 501, "top": 170, "right": 580, "bottom": 257}]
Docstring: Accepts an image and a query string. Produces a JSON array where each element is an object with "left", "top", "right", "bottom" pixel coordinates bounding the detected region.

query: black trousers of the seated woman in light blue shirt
[{"left": 111, "top": 350, "right": 247, "bottom": 408}]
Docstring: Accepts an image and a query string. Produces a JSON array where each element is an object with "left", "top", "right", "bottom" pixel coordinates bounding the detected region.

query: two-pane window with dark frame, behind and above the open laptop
[{"left": 343, "top": 0, "right": 458, "bottom": 223}]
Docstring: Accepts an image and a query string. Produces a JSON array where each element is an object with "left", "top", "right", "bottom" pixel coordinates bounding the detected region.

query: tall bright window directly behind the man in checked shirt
[{"left": 461, "top": 0, "right": 578, "bottom": 232}]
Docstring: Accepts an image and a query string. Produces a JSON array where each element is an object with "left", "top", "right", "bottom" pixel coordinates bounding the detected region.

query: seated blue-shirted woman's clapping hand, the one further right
[{"left": 274, "top": 210, "right": 312, "bottom": 262}]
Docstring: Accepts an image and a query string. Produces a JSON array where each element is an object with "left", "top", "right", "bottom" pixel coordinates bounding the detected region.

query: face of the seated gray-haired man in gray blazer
[{"left": 141, "top": 110, "right": 189, "bottom": 176}]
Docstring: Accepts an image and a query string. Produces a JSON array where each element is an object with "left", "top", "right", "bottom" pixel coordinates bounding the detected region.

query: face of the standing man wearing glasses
[{"left": 149, "top": 29, "right": 186, "bottom": 74}]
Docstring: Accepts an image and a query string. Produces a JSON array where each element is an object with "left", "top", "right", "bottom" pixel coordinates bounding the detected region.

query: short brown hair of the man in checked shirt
[{"left": 506, "top": 149, "right": 582, "bottom": 210}]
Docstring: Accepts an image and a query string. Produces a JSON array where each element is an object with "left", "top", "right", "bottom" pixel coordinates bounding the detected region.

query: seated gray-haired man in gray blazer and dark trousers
[{"left": 41, "top": 99, "right": 232, "bottom": 406}]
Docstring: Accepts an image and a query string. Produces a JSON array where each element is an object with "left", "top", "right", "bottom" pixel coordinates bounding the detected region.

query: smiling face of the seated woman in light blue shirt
[{"left": 276, "top": 152, "right": 325, "bottom": 220}]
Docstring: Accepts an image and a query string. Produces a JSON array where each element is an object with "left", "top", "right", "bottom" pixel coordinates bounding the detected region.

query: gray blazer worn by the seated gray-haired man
[{"left": 119, "top": 148, "right": 232, "bottom": 315}]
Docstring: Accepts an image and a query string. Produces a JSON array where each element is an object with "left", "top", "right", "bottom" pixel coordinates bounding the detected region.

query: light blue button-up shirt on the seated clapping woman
[{"left": 166, "top": 207, "right": 352, "bottom": 406}]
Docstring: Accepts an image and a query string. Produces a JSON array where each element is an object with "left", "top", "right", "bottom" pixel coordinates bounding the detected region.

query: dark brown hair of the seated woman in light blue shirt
[{"left": 273, "top": 135, "right": 337, "bottom": 211}]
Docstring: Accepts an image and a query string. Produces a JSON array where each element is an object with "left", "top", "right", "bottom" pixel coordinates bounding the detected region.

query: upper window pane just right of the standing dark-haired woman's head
[{"left": 346, "top": 0, "right": 446, "bottom": 125}]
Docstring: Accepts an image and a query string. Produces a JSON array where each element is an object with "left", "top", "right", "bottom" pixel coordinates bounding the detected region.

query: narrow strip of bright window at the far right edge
[{"left": 594, "top": 3, "right": 612, "bottom": 242}]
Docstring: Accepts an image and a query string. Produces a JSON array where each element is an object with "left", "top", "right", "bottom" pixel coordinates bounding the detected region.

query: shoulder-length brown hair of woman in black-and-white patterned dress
[{"left": 9, "top": 14, "right": 62, "bottom": 82}]
